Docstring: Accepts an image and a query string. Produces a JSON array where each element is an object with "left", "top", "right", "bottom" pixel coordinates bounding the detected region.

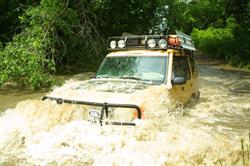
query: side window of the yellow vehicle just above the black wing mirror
[{"left": 172, "top": 56, "right": 190, "bottom": 80}]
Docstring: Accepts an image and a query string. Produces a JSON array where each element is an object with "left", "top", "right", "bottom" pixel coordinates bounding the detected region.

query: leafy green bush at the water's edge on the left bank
[{"left": 0, "top": 24, "right": 53, "bottom": 88}]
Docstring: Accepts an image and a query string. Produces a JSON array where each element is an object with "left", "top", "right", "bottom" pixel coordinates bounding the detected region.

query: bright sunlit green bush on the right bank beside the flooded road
[{"left": 192, "top": 17, "right": 250, "bottom": 68}]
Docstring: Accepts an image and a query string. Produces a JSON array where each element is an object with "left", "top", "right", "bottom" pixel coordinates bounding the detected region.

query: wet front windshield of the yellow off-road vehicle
[{"left": 97, "top": 56, "right": 167, "bottom": 83}]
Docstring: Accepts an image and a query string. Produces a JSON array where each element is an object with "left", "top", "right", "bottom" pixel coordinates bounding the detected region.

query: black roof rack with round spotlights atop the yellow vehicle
[{"left": 108, "top": 31, "right": 196, "bottom": 51}]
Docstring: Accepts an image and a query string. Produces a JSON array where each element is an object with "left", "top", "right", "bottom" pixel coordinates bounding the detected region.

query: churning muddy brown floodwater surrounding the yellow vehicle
[{"left": 0, "top": 63, "right": 250, "bottom": 166}]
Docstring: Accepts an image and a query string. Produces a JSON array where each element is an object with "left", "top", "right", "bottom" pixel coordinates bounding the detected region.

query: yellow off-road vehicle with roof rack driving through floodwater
[{"left": 43, "top": 31, "right": 199, "bottom": 125}]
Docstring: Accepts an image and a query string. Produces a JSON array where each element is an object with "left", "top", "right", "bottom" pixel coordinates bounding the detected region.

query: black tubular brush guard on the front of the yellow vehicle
[{"left": 42, "top": 96, "right": 142, "bottom": 126}]
